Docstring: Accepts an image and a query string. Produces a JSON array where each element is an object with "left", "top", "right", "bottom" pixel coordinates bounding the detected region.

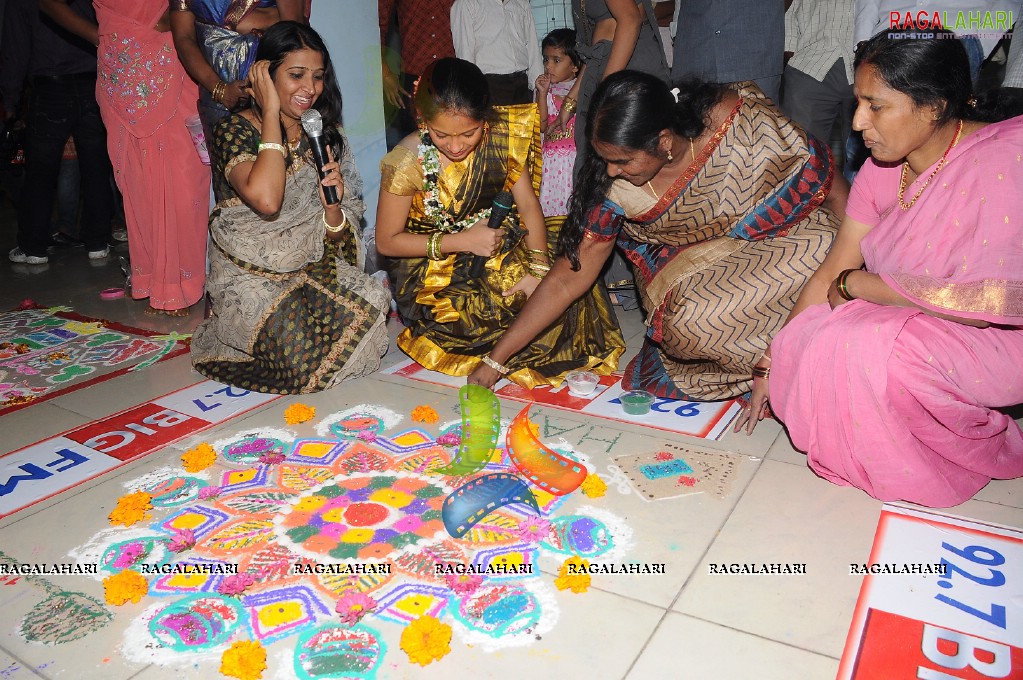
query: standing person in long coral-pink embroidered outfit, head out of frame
[{"left": 40, "top": 0, "right": 210, "bottom": 316}]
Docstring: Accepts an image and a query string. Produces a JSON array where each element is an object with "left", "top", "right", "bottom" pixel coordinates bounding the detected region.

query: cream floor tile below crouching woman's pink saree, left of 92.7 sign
[{"left": 672, "top": 460, "right": 881, "bottom": 658}]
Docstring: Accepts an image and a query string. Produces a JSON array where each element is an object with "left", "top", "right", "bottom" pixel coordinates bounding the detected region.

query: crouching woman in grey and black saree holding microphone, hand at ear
[{"left": 192, "top": 21, "right": 390, "bottom": 394}]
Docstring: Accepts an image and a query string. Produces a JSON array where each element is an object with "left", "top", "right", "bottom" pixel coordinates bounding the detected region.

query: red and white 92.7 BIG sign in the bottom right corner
[{"left": 838, "top": 505, "right": 1023, "bottom": 680}]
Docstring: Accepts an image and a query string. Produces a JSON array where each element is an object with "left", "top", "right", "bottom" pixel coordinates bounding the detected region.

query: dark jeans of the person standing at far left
[{"left": 17, "top": 74, "right": 114, "bottom": 257}]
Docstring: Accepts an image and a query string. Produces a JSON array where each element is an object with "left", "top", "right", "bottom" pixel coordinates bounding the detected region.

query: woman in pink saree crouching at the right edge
[{"left": 737, "top": 31, "right": 1023, "bottom": 507}]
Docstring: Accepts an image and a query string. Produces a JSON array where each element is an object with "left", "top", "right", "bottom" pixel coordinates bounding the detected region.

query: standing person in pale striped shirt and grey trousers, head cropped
[{"left": 782, "top": 0, "right": 855, "bottom": 144}]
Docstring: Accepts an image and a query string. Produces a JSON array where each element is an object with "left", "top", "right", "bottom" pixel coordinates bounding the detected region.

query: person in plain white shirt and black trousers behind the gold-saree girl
[{"left": 451, "top": 0, "right": 543, "bottom": 105}]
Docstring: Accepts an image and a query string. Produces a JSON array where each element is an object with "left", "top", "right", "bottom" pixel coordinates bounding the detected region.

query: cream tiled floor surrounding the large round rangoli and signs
[{"left": 0, "top": 241, "right": 1023, "bottom": 680}]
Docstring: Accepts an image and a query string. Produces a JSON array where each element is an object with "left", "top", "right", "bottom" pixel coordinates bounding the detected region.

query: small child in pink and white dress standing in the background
[{"left": 536, "top": 29, "right": 582, "bottom": 217}]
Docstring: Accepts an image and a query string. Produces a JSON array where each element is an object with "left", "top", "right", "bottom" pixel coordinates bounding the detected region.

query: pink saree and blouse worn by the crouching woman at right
[{"left": 770, "top": 119, "right": 1023, "bottom": 507}]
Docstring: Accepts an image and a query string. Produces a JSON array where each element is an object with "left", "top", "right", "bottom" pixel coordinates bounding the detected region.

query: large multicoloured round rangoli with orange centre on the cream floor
[{"left": 61, "top": 398, "right": 631, "bottom": 679}]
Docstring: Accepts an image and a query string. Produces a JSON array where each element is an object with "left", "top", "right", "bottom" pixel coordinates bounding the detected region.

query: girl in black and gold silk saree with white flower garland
[{"left": 376, "top": 58, "right": 625, "bottom": 389}]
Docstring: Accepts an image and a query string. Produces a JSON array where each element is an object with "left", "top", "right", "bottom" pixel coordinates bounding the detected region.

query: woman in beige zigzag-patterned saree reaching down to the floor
[{"left": 470, "top": 71, "right": 847, "bottom": 401}]
